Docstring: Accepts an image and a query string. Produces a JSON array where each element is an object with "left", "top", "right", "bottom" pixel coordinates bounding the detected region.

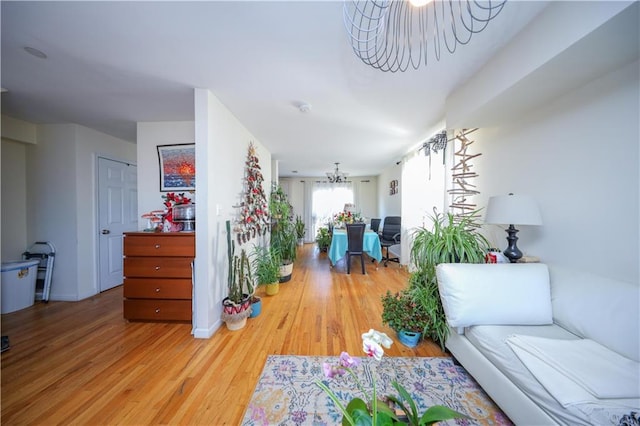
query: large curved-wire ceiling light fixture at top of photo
[{"left": 344, "top": 0, "right": 507, "bottom": 72}]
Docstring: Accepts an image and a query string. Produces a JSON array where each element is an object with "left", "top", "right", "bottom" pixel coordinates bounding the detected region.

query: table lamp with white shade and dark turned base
[{"left": 484, "top": 194, "right": 542, "bottom": 263}]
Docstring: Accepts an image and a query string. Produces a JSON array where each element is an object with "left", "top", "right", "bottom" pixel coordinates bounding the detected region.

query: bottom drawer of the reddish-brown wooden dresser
[{"left": 124, "top": 299, "right": 192, "bottom": 321}]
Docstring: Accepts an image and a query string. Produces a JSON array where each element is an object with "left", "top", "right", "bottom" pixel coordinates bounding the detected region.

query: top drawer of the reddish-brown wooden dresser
[{"left": 124, "top": 233, "right": 196, "bottom": 257}]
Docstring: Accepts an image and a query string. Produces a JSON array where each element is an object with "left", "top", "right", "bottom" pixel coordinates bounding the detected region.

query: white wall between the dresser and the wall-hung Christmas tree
[{"left": 194, "top": 89, "right": 271, "bottom": 338}]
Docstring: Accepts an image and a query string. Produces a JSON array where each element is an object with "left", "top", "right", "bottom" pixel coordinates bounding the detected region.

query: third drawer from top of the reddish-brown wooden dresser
[{"left": 124, "top": 278, "right": 191, "bottom": 300}]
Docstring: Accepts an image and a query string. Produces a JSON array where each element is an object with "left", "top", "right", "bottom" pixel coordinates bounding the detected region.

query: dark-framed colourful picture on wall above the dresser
[{"left": 158, "top": 143, "right": 196, "bottom": 192}]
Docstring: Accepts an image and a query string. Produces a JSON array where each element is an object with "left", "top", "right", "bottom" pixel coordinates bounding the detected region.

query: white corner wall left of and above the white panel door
[{"left": 17, "top": 124, "right": 135, "bottom": 301}]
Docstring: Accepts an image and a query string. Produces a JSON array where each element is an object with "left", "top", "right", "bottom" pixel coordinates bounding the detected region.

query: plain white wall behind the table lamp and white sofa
[{"left": 476, "top": 62, "right": 640, "bottom": 283}]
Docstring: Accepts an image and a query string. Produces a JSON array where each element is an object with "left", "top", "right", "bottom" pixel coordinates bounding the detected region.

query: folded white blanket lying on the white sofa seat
[{"left": 506, "top": 335, "right": 640, "bottom": 407}]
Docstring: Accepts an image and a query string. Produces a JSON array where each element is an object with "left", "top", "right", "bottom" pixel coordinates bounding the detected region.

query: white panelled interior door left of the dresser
[{"left": 98, "top": 157, "right": 138, "bottom": 292}]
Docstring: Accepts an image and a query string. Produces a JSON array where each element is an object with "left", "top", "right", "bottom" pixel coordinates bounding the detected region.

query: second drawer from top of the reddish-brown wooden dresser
[{"left": 124, "top": 257, "right": 192, "bottom": 278}]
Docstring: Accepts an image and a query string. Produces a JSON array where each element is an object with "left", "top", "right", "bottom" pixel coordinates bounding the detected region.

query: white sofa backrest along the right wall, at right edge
[{"left": 549, "top": 265, "right": 640, "bottom": 361}]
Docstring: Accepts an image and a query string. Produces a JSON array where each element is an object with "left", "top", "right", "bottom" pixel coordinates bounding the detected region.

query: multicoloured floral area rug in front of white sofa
[{"left": 242, "top": 355, "right": 512, "bottom": 426}]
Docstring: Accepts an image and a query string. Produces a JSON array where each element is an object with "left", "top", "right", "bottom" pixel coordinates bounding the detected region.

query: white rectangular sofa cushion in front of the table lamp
[{"left": 436, "top": 263, "right": 553, "bottom": 327}]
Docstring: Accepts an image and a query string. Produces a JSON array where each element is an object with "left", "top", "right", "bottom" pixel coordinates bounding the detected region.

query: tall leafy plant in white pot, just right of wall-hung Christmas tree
[{"left": 269, "top": 185, "right": 296, "bottom": 283}]
